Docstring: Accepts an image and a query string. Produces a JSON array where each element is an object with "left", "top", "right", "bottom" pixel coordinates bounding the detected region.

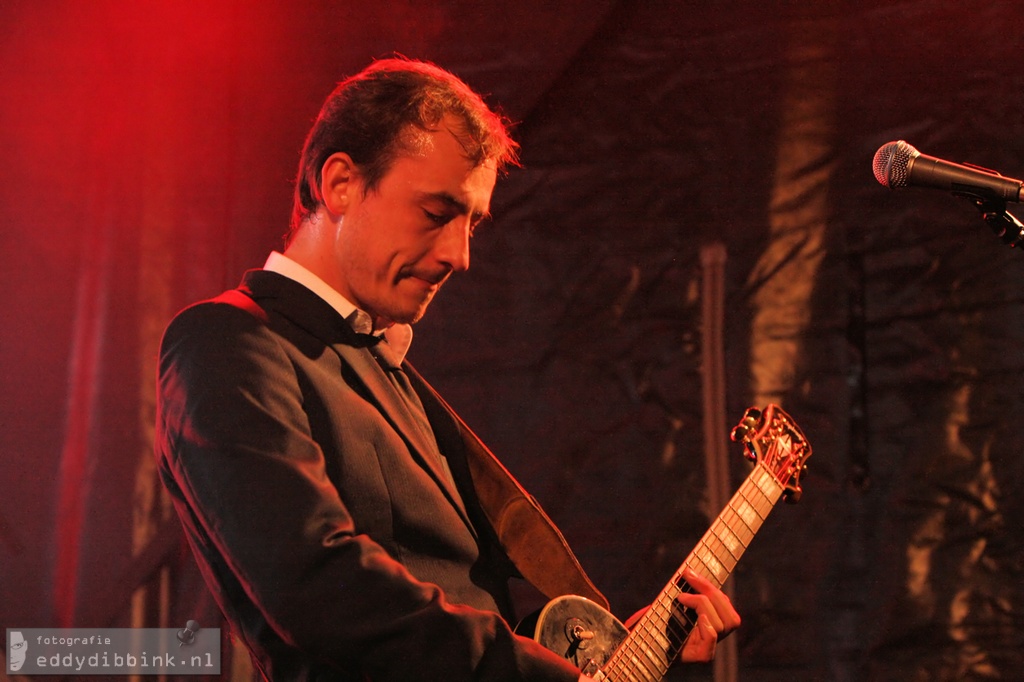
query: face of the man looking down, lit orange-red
[{"left": 334, "top": 124, "right": 497, "bottom": 327}]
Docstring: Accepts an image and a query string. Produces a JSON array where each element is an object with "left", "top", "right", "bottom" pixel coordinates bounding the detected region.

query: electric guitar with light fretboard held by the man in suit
[{"left": 517, "top": 404, "right": 811, "bottom": 682}]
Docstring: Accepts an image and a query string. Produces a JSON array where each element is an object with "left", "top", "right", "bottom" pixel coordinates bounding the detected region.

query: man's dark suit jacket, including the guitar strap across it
[{"left": 157, "top": 270, "right": 606, "bottom": 681}]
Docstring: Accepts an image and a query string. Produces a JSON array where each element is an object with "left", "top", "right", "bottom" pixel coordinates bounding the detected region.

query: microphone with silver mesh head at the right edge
[{"left": 872, "top": 140, "right": 1024, "bottom": 203}]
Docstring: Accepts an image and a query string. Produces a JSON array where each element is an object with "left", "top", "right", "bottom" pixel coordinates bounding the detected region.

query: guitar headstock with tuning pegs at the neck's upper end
[{"left": 730, "top": 404, "right": 811, "bottom": 502}]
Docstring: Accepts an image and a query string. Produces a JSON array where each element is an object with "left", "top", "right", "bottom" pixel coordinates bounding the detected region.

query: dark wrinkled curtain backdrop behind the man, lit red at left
[{"left": 0, "top": 0, "right": 1024, "bottom": 682}]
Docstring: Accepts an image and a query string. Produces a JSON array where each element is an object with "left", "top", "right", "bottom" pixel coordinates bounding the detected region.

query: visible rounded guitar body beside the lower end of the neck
[{"left": 516, "top": 595, "right": 629, "bottom": 675}]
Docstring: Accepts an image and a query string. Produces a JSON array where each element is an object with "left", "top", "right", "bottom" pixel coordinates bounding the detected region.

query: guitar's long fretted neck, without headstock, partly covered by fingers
[{"left": 601, "top": 464, "right": 784, "bottom": 682}]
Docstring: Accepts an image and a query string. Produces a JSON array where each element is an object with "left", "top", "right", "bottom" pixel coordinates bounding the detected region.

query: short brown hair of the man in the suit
[{"left": 288, "top": 57, "right": 518, "bottom": 241}]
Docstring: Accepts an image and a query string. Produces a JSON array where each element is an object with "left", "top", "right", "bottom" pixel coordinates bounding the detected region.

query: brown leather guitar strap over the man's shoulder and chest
[{"left": 213, "top": 289, "right": 608, "bottom": 609}]
